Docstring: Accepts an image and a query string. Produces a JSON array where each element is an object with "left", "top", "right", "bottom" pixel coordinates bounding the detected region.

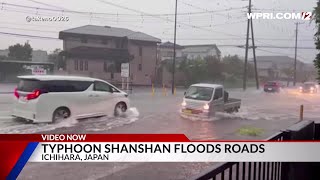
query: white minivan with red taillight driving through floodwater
[{"left": 12, "top": 75, "right": 129, "bottom": 122}]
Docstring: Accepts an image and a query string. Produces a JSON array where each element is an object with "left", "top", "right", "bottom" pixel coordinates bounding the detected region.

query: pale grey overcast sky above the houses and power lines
[{"left": 0, "top": 0, "right": 317, "bottom": 62}]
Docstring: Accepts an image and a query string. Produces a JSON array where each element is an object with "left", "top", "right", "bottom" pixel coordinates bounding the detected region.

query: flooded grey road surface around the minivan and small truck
[{"left": 0, "top": 84, "right": 320, "bottom": 179}]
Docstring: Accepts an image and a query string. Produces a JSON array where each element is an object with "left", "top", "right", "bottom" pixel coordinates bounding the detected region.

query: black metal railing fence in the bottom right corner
[{"left": 192, "top": 122, "right": 320, "bottom": 180}]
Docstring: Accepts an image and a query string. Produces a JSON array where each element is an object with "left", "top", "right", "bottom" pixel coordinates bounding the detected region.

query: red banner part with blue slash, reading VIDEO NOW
[{"left": 0, "top": 134, "right": 189, "bottom": 179}]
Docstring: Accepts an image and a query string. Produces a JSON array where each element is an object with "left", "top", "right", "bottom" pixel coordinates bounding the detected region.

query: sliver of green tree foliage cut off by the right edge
[{"left": 313, "top": 1, "right": 320, "bottom": 80}]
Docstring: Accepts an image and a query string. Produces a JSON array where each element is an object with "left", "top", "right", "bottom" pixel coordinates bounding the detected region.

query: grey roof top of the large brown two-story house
[{"left": 59, "top": 25, "right": 161, "bottom": 42}]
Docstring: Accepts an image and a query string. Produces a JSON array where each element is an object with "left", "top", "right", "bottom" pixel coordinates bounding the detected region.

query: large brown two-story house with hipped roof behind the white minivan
[{"left": 59, "top": 25, "right": 161, "bottom": 85}]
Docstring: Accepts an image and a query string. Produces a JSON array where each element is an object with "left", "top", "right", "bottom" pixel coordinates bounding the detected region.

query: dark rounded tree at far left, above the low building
[{"left": 8, "top": 43, "right": 32, "bottom": 61}]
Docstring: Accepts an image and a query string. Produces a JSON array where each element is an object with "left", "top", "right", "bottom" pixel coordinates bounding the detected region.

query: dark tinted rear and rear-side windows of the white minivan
[{"left": 18, "top": 79, "right": 92, "bottom": 92}]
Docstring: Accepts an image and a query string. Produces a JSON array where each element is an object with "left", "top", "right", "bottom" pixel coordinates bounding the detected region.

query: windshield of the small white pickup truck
[{"left": 185, "top": 86, "right": 214, "bottom": 101}]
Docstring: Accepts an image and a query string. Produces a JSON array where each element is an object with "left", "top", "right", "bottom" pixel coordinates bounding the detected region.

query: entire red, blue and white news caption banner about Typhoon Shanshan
[{"left": 0, "top": 134, "right": 320, "bottom": 179}]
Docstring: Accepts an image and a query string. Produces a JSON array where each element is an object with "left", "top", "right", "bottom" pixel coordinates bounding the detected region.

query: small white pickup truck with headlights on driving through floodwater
[{"left": 181, "top": 84, "right": 241, "bottom": 118}]
